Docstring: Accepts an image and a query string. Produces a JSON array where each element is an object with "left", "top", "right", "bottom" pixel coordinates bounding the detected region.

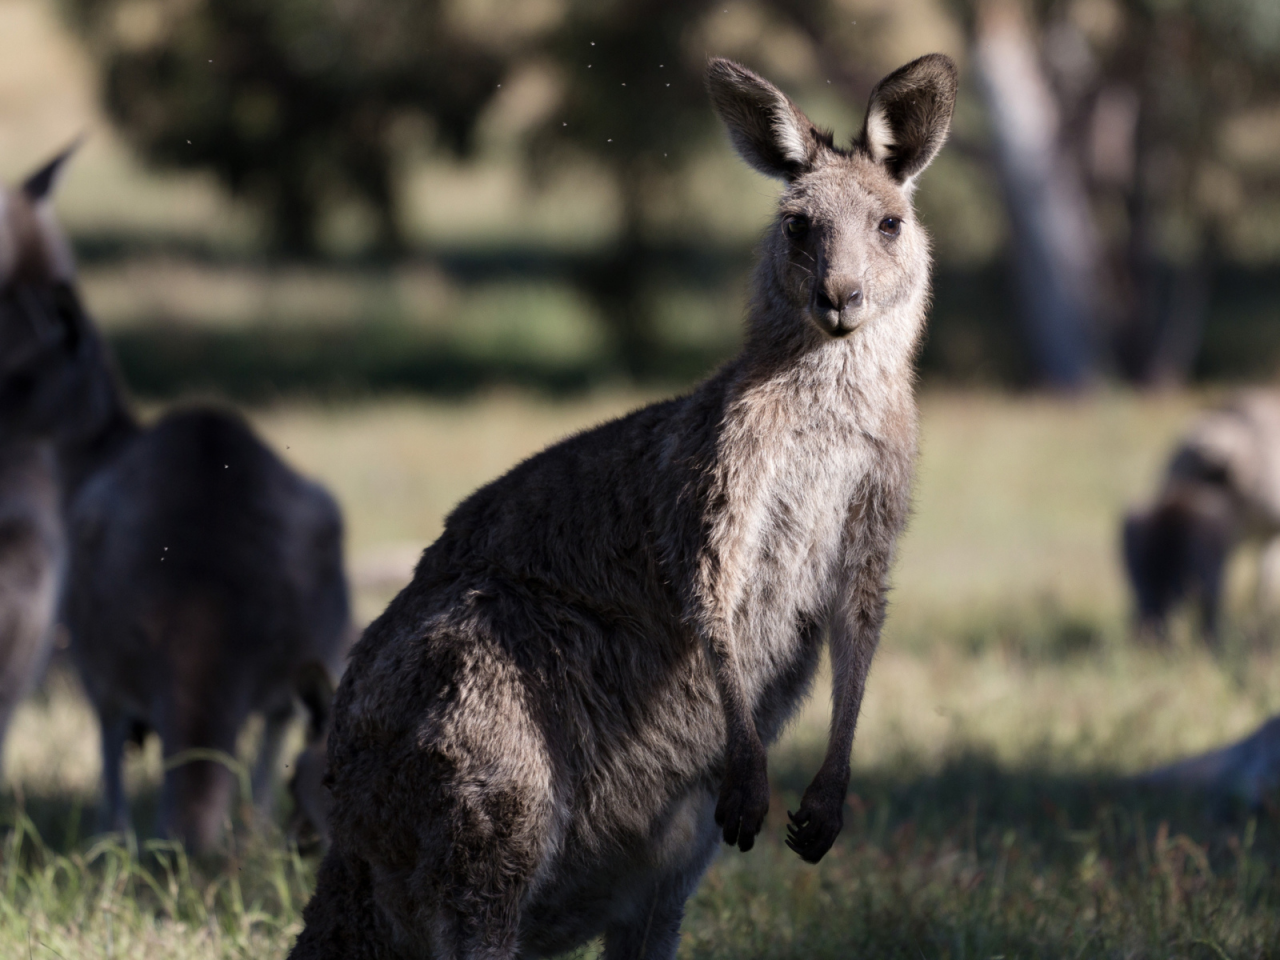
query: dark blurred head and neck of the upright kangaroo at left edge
[{"left": 0, "top": 148, "right": 109, "bottom": 448}]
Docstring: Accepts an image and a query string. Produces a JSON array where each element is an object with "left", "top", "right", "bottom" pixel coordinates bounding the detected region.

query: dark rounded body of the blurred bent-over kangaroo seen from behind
[{"left": 67, "top": 410, "right": 349, "bottom": 847}]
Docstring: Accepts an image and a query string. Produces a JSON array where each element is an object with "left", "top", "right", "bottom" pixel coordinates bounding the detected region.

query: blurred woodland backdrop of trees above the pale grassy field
[{"left": 0, "top": 0, "right": 1280, "bottom": 399}]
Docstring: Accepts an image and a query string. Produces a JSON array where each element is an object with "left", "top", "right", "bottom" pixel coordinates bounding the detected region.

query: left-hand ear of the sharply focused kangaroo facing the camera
[{"left": 707, "top": 58, "right": 823, "bottom": 180}]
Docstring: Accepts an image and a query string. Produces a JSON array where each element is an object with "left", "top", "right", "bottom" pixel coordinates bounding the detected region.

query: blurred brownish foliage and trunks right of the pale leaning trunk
[{"left": 956, "top": 0, "right": 1280, "bottom": 383}]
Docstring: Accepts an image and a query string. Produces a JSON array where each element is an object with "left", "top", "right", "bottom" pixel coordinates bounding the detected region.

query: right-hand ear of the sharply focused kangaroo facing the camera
[{"left": 861, "top": 54, "right": 956, "bottom": 183}]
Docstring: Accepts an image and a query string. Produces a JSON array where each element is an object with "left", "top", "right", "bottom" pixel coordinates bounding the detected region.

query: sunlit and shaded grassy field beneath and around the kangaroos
[{"left": 0, "top": 393, "right": 1280, "bottom": 960}]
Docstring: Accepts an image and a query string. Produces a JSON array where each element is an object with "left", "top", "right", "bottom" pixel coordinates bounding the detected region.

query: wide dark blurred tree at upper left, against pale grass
[{"left": 67, "top": 0, "right": 509, "bottom": 255}]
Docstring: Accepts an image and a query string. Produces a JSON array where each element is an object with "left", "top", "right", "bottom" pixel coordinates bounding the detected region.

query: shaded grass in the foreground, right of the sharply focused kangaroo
[{"left": 681, "top": 755, "right": 1280, "bottom": 960}]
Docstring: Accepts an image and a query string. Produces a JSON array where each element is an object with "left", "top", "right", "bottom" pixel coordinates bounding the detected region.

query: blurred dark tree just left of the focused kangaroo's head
[{"left": 530, "top": 0, "right": 873, "bottom": 374}]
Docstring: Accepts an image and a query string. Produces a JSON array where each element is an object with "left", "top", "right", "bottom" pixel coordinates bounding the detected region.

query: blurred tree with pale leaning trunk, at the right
[{"left": 956, "top": 0, "right": 1280, "bottom": 385}]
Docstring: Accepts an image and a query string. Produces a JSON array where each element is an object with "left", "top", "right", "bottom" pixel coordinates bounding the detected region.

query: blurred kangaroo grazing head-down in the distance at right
[{"left": 1123, "top": 390, "right": 1280, "bottom": 643}]
